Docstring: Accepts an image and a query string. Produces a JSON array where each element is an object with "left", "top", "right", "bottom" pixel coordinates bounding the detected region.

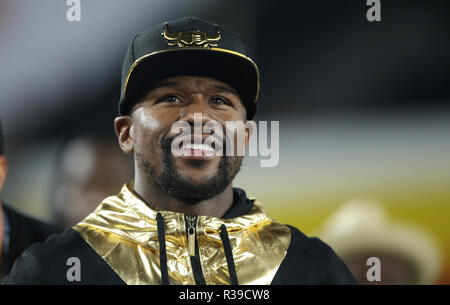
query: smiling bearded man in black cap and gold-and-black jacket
[{"left": 1, "top": 18, "right": 356, "bottom": 284}]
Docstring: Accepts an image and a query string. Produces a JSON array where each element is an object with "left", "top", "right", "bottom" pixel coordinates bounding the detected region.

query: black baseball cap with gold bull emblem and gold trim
[{"left": 119, "top": 17, "right": 260, "bottom": 119}]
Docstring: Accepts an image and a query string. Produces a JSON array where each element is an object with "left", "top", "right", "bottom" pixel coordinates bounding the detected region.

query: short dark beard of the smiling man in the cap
[{"left": 135, "top": 136, "right": 242, "bottom": 204}]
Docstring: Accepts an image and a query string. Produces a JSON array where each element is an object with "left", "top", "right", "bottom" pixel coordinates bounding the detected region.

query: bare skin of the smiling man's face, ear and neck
[{"left": 114, "top": 76, "right": 250, "bottom": 217}]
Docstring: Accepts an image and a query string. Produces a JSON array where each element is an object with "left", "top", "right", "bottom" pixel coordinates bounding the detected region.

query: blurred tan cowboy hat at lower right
[{"left": 317, "top": 199, "right": 442, "bottom": 284}]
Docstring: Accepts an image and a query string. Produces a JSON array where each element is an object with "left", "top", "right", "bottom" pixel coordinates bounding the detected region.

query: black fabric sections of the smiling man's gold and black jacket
[{"left": 4, "top": 189, "right": 357, "bottom": 285}]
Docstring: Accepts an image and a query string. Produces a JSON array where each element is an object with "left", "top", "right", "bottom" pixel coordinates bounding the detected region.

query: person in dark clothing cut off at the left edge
[{"left": 0, "top": 118, "right": 62, "bottom": 279}]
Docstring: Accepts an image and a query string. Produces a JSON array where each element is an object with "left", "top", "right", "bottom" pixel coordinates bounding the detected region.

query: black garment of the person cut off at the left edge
[{"left": 0, "top": 203, "right": 63, "bottom": 278}]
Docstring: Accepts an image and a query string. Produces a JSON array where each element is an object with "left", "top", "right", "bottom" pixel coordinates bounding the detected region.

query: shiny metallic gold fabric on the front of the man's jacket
[{"left": 74, "top": 184, "right": 291, "bottom": 285}]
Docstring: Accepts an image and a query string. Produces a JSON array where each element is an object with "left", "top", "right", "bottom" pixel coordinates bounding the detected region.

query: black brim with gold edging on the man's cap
[{"left": 119, "top": 48, "right": 260, "bottom": 119}]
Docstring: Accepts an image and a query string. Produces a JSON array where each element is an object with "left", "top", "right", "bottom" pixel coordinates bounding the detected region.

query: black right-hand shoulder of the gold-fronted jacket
[{"left": 272, "top": 225, "right": 357, "bottom": 285}]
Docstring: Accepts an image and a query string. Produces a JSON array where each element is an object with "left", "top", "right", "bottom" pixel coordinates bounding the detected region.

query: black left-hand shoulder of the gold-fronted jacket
[{"left": 3, "top": 229, "right": 124, "bottom": 285}]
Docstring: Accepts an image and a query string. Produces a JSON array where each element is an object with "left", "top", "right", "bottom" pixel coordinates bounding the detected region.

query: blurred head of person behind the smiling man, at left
[{"left": 53, "top": 135, "right": 133, "bottom": 227}]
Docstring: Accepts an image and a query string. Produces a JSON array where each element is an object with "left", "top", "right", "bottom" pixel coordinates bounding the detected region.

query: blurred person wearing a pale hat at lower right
[{"left": 318, "top": 199, "right": 442, "bottom": 285}]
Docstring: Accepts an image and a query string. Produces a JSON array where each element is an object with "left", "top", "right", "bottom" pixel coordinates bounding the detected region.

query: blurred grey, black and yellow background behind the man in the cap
[{"left": 0, "top": 0, "right": 450, "bottom": 284}]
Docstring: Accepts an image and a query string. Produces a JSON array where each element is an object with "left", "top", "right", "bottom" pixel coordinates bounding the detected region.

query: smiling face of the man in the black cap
[{"left": 119, "top": 76, "right": 248, "bottom": 203}]
